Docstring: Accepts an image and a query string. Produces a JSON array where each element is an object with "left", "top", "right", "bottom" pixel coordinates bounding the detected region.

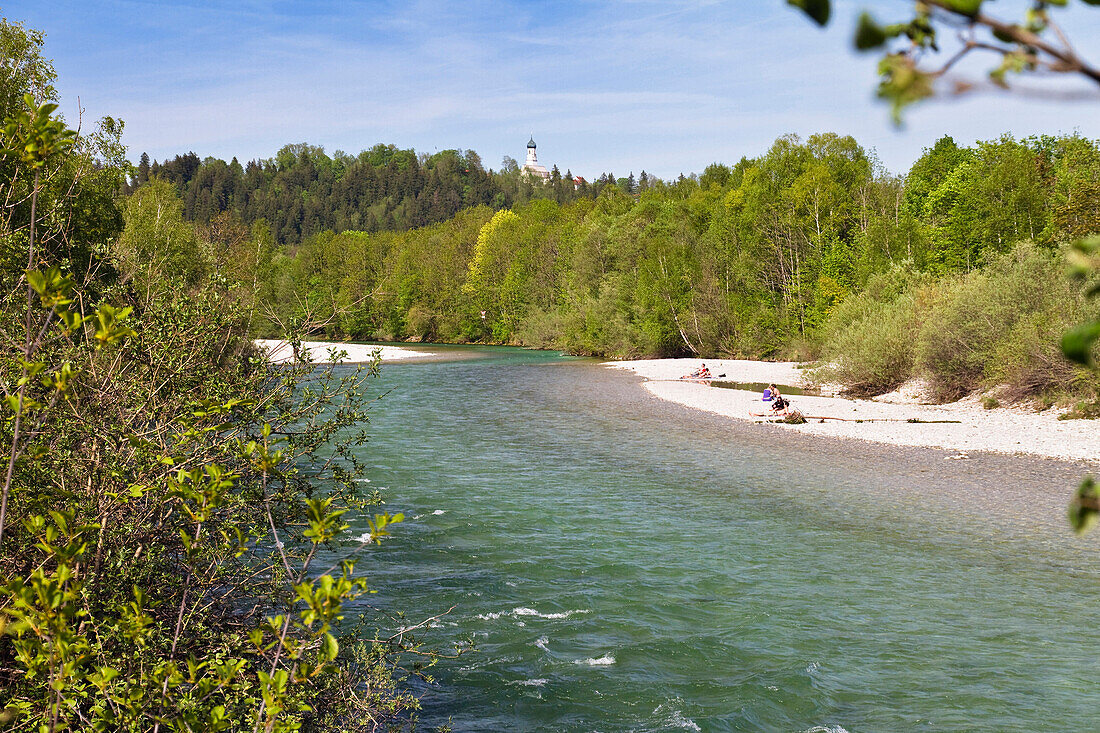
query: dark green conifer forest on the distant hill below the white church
[{"left": 136, "top": 143, "right": 648, "bottom": 244}]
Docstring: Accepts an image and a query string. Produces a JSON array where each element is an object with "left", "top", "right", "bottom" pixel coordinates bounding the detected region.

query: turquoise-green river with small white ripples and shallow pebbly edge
[{"left": 343, "top": 346, "right": 1100, "bottom": 733}]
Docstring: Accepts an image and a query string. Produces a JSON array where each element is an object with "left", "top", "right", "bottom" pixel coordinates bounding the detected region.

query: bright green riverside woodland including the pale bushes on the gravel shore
[{"left": 195, "top": 133, "right": 1100, "bottom": 400}]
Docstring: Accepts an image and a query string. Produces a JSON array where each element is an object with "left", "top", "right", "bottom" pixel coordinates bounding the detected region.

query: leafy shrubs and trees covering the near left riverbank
[{"left": 0, "top": 18, "right": 446, "bottom": 731}]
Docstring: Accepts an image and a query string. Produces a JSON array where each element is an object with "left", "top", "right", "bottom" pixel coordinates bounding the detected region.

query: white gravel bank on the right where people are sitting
[{"left": 604, "top": 359, "right": 1100, "bottom": 464}]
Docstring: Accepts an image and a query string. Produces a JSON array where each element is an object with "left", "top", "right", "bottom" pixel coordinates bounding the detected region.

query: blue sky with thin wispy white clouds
[{"left": 12, "top": 0, "right": 1100, "bottom": 177}]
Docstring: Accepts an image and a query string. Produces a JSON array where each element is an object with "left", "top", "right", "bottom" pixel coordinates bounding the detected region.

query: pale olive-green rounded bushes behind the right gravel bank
[{"left": 815, "top": 243, "right": 1097, "bottom": 402}]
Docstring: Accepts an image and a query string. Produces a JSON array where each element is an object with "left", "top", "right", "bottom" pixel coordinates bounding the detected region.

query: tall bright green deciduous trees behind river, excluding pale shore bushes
[{"left": 265, "top": 133, "right": 1100, "bottom": 395}]
